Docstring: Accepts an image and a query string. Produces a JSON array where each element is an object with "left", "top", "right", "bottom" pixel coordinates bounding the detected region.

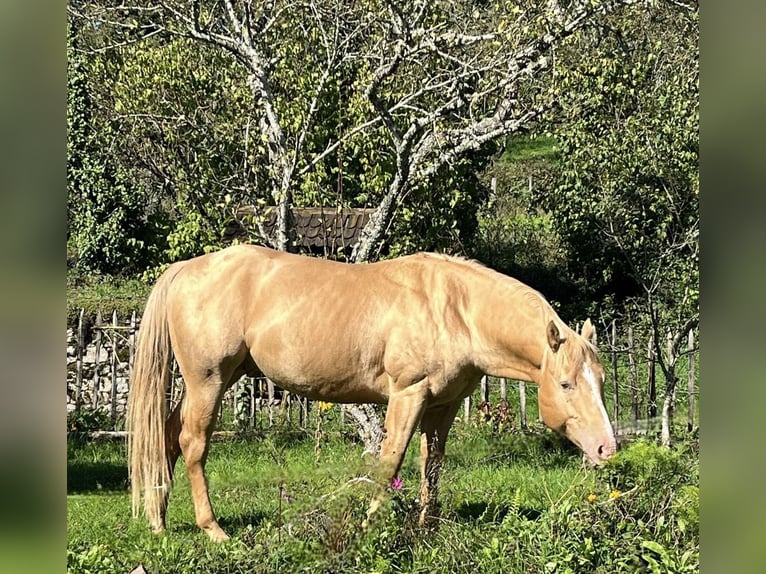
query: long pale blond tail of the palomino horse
[{"left": 126, "top": 264, "right": 181, "bottom": 526}]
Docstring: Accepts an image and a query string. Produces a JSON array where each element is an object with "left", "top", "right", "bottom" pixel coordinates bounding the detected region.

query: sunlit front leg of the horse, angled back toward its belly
[{"left": 363, "top": 379, "right": 428, "bottom": 527}]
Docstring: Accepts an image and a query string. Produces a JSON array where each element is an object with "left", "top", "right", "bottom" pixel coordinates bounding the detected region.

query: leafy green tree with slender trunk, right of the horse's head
[{"left": 539, "top": 2, "right": 699, "bottom": 443}]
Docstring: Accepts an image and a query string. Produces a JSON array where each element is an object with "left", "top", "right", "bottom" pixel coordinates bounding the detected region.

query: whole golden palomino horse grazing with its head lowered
[{"left": 127, "top": 245, "right": 616, "bottom": 541}]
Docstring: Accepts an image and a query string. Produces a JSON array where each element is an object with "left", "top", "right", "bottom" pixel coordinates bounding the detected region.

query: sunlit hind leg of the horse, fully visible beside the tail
[{"left": 178, "top": 375, "right": 229, "bottom": 542}]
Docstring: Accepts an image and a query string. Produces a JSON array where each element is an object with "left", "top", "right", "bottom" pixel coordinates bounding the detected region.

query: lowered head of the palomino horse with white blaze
[{"left": 539, "top": 319, "right": 617, "bottom": 465}]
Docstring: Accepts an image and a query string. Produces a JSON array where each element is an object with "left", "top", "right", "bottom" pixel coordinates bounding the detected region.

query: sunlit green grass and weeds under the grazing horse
[{"left": 67, "top": 425, "right": 699, "bottom": 574}]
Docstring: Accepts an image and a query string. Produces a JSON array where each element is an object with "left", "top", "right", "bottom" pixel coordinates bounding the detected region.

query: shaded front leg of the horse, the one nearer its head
[{"left": 419, "top": 401, "right": 462, "bottom": 525}]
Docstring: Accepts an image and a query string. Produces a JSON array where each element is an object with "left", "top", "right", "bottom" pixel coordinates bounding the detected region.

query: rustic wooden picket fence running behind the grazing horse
[{"left": 67, "top": 311, "right": 699, "bottom": 435}]
